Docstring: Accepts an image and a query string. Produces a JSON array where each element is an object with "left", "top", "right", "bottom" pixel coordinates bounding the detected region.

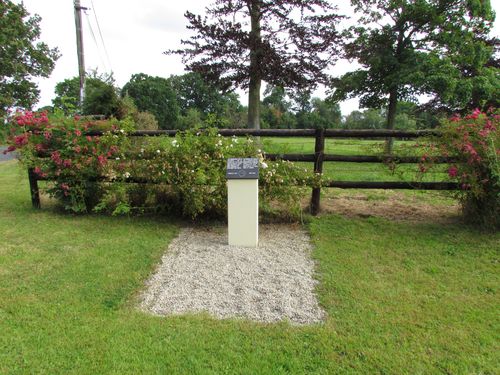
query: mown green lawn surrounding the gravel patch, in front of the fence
[{"left": 0, "top": 162, "right": 500, "bottom": 374}]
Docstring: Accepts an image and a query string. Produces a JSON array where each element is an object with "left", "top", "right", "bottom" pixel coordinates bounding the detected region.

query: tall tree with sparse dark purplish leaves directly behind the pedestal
[{"left": 167, "top": 0, "right": 340, "bottom": 129}]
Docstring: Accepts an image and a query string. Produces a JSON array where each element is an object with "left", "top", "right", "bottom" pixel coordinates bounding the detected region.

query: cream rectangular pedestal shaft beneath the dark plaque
[{"left": 227, "top": 179, "right": 259, "bottom": 247}]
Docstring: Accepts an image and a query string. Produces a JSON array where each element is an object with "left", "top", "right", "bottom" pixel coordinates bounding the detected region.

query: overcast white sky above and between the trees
[{"left": 14, "top": 0, "right": 500, "bottom": 115}]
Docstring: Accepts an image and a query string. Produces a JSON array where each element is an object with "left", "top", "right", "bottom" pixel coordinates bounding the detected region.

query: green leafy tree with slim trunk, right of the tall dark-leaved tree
[{"left": 333, "top": 0, "right": 494, "bottom": 153}]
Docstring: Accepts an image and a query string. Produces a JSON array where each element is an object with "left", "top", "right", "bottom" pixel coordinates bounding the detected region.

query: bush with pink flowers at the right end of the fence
[{"left": 420, "top": 110, "right": 500, "bottom": 228}]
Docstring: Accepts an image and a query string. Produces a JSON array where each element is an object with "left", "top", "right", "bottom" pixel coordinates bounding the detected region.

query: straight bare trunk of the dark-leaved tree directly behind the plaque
[{"left": 248, "top": 0, "right": 262, "bottom": 129}]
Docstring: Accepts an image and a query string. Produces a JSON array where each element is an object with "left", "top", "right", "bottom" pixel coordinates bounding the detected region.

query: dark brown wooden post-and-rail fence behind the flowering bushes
[{"left": 28, "top": 129, "right": 460, "bottom": 215}]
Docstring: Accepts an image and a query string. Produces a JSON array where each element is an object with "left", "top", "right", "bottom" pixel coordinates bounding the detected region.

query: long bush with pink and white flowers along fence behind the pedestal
[{"left": 4, "top": 112, "right": 319, "bottom": 219}]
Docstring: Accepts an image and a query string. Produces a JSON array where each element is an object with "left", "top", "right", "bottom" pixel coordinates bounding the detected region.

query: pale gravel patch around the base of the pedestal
[{"left": 141, "top": 226, "right": 325, "bottom": 324}]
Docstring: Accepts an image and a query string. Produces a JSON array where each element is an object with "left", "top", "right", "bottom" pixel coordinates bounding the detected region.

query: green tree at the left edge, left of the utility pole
[{"left": 0, "top": 0, "right": 59, "bottom": 117}]
